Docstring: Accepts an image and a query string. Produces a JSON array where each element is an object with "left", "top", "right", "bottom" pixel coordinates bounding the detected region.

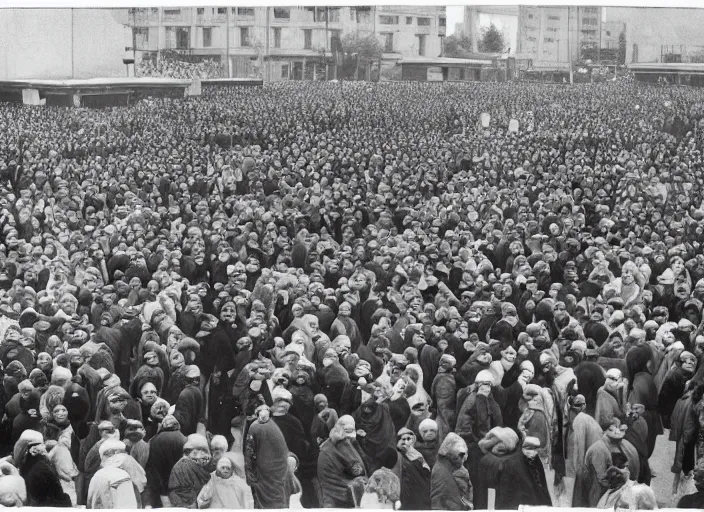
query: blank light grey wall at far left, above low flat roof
[{"left": 0, "top": 9, "right": 131, "bottom": 80}]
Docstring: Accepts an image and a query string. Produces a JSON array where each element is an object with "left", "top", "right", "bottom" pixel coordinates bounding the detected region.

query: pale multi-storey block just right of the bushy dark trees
[{"left": 517, "top": 6, "right": 602, "bottom": 67}]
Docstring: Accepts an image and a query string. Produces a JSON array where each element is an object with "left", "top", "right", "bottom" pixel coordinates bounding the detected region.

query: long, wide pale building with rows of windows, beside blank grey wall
[{"left": 128, "top": 6, "right": 446, "bottom": 80}]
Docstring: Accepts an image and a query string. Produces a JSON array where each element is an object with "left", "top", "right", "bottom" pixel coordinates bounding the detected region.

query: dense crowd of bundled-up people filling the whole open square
[{"left": 0, "top": 82, "right": 704, "bottom": 510}]
